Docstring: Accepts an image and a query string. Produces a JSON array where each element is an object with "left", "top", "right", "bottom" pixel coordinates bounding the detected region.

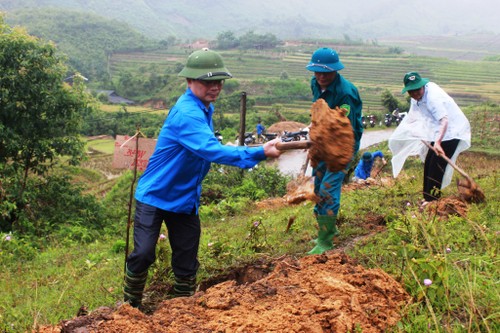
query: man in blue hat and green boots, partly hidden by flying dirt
[{"left": 306, "top": 47, "right": 363, "bottom": 254}]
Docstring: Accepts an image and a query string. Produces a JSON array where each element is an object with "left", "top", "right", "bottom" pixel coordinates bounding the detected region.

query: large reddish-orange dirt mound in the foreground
[{"left": 39, "top": 252, "right": 410, "bottom": 333}]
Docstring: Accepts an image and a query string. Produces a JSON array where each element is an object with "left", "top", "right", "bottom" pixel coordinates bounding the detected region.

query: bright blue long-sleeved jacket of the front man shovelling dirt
[{"left": 135, "top": 88, "right": 266, "bottom": 214}]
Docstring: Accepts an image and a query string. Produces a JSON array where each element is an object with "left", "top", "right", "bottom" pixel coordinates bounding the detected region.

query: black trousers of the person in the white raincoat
[{"left": 423, "top": 139, "right": 460, "bottom": 201}]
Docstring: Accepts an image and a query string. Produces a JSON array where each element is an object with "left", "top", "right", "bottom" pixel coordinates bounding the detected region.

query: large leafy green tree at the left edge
[{"left": 0, "top": 17, "right": 95, "bottom": 228}]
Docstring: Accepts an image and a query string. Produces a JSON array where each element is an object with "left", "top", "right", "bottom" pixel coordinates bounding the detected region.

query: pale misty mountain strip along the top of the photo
[{"left": 0, "top": 0, "right": 500, "bottom": 39}]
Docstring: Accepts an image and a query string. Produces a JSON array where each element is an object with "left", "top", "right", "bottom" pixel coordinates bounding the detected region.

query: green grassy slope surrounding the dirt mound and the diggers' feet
[{"left": 0, "top": 144, "right": 500, "bottom": 332}]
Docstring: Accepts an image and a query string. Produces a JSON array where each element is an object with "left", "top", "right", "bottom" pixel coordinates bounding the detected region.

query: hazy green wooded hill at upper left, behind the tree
[{"left": 2, "top": 9, "right": 158, "bottom": 81}]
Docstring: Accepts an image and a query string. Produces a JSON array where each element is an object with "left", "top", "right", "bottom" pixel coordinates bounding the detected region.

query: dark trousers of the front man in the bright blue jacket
[{"left": 127, "top": 201, "right": 201, "bottom": 277}]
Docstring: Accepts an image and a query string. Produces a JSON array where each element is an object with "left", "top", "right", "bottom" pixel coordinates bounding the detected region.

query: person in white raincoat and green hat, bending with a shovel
[{"left": 389, "top": 72, "right": 471, "bottom": 204}]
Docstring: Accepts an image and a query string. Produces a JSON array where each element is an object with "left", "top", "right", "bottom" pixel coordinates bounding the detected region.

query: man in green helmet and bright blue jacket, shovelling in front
[{"left": 124, "top": 49, "right": 280, "bottom": 307}]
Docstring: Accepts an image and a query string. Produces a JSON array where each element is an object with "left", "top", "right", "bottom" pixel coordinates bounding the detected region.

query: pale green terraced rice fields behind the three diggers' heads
[{"left": 110, "top": 46, "right": 500, "bottom": 114}]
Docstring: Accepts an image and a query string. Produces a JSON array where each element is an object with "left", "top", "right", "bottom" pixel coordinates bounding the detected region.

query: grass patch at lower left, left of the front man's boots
[{"left": 0, "top": 239, "right": 123, "bottom": 332}]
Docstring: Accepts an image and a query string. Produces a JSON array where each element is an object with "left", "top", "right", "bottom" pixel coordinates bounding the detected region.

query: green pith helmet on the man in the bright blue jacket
[{"left": 178, "top": 48, "right": 233, "bottom": 81}]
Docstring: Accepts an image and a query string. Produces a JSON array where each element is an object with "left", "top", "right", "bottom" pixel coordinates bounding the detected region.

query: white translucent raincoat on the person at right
[{"left": 389, "top": 82, "right": 471, "bottom": 189}]
